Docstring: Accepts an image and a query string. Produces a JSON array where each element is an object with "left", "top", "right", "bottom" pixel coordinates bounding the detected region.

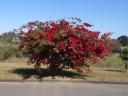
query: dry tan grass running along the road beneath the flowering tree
[{"left": 0, "top": 57, "right": 128, "bottom": 82}]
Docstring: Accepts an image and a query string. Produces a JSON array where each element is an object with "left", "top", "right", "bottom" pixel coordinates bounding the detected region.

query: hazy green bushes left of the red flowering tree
[{"left": 0, "top": 30, "right": 22, "bottom": 60}]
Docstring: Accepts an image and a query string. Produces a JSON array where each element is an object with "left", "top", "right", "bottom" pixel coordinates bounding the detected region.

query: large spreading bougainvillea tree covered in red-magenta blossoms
[{"left": 19, "top": 18, "right": 112, "bottom": 72}]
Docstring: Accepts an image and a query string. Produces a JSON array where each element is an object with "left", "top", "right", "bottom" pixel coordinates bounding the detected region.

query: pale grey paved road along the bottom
[{"left": 0, "top": 82, "right": 128, "bottom": 96}]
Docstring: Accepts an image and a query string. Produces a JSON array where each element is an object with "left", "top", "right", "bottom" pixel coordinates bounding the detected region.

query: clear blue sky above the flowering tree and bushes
[{"left": 0, "top": 0, "right": 128, "bottom": 38}]
